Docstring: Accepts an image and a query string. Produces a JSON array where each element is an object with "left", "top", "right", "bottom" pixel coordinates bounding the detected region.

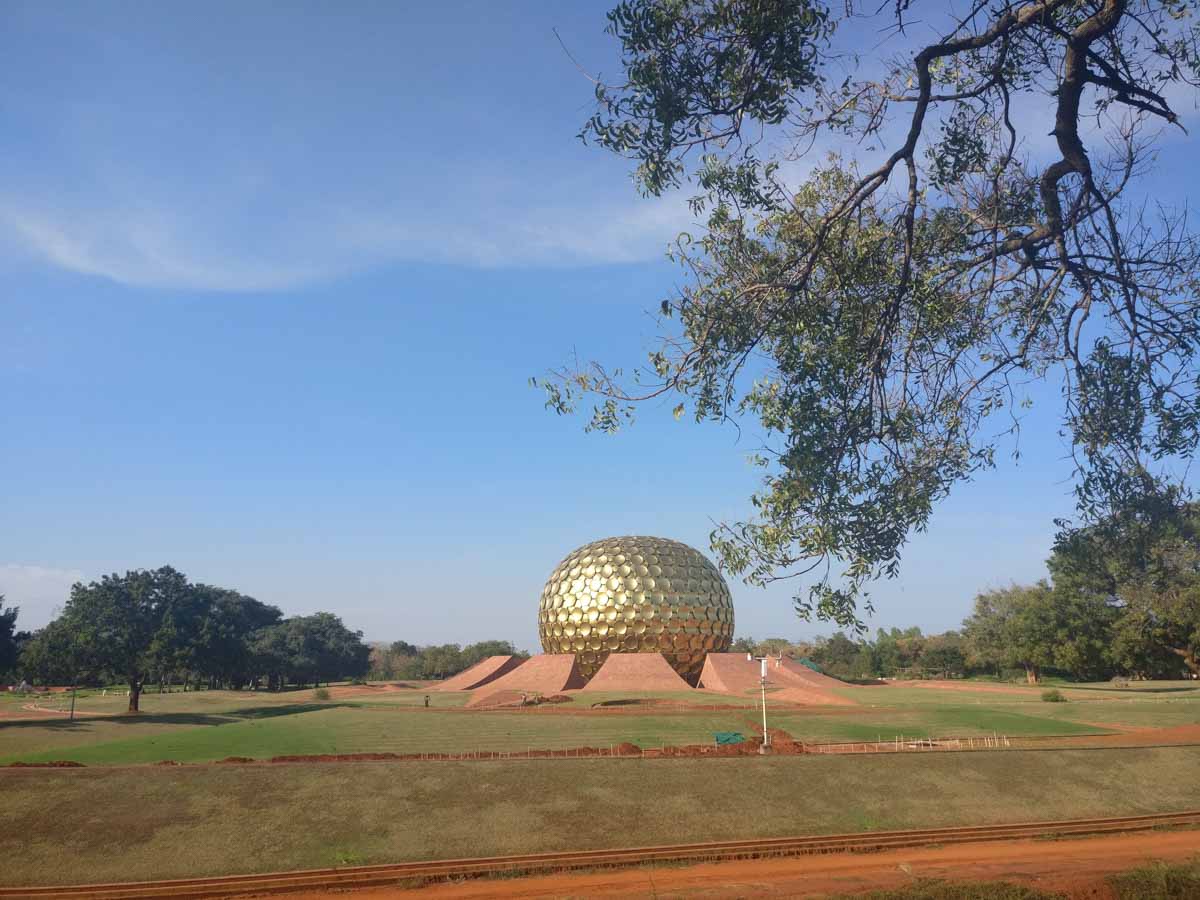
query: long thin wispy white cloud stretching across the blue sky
[{"left": 0, "top": 192, "right": 690, "bottom": 292}]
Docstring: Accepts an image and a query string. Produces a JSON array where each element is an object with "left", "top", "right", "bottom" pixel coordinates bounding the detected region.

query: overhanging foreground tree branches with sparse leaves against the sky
[{"left": 535, "top": 0, "right": 1200, "bottom": 626}]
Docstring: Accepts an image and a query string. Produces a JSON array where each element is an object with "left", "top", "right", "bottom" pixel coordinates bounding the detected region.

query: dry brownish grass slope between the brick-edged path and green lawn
[{"left": 0, "top": 748, "right": 1200, "bottom": 884}]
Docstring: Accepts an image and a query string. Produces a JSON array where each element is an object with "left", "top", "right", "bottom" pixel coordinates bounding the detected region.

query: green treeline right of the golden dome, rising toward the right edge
[{"left": 736, "top": 496, "right": 1200, "bottom": 683}]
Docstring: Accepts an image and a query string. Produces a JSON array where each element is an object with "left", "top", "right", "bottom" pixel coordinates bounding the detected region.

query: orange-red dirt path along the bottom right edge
[{"left": 280, "top": 830, "right": 1200, "bottom": 900}]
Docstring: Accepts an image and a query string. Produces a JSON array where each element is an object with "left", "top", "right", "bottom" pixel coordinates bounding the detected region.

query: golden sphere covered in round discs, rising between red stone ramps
[{"left": 538, "top": 536, "right": 733, "bottom": 682}]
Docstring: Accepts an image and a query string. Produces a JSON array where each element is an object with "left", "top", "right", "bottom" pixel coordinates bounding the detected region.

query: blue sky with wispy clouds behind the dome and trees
[{"left": 0, "top": 0, "right": 1200, "bottom": 650}]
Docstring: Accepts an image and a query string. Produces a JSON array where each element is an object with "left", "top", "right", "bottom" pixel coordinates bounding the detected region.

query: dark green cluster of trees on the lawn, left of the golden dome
[{"left": 0, "top": 566, "right": 370, "bottom": 712}]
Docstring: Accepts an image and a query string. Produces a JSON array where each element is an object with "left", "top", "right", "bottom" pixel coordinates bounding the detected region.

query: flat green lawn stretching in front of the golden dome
[{"left": 0, "top": 683, "right": 1200, "bottom": 766}]
